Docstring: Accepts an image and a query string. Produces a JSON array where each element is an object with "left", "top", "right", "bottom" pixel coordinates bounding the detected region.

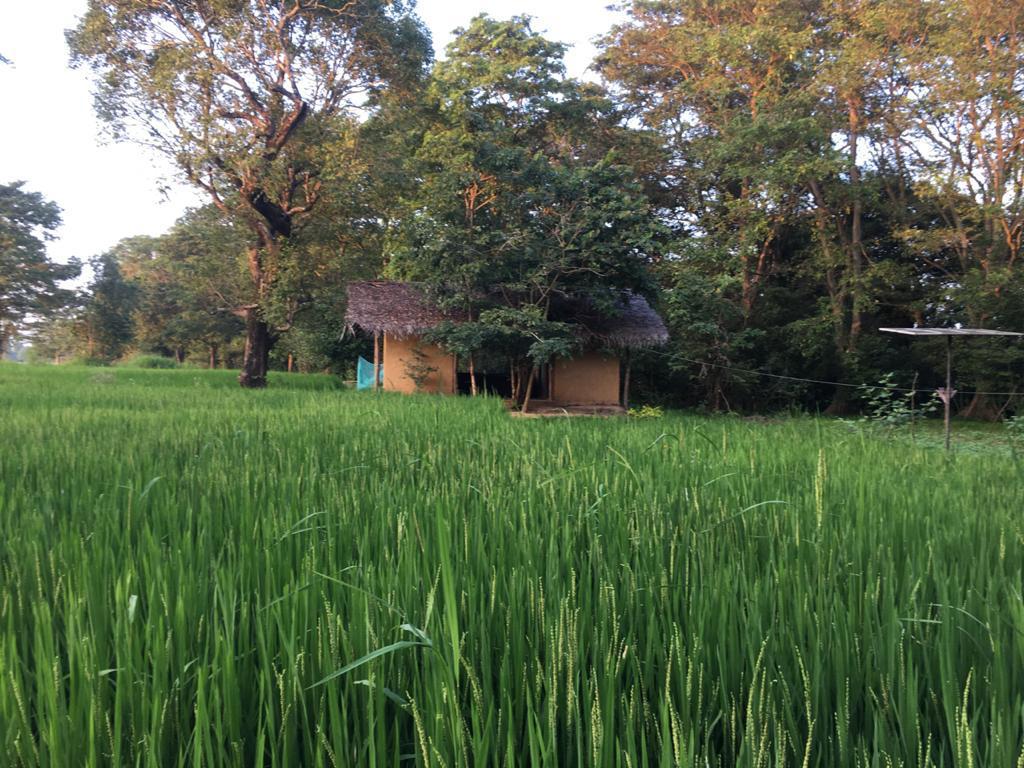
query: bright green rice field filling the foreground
[{"left": 0, "top": 365, "right": 1024, "bottom": 767}]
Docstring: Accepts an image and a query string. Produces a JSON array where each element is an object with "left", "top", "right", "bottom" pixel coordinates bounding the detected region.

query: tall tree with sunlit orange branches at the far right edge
[{"left": 898, "top": 0, "right": 1024, "bottom": 418}]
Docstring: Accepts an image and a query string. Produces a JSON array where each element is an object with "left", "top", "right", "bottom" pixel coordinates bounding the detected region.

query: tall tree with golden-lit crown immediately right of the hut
[{"left": 598, "top": 0, "right": 836, "bottom": 407}]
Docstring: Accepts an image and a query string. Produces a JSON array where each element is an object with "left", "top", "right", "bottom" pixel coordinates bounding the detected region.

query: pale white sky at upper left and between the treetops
[{"left": 0, "top": 0, "right": 617, "bottom": 270}]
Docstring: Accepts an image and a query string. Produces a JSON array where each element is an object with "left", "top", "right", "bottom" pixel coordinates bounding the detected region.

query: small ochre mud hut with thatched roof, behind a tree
[{"left": 345, "top": 281, "right": 669, "bottom": 406}]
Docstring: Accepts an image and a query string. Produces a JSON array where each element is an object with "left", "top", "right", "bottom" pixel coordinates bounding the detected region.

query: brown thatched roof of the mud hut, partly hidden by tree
[{"left": 345, "top": 281, "right": 669, "bottom": 348}]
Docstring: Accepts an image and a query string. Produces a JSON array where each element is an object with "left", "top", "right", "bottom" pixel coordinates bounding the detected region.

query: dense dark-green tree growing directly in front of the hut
[{"left": 390, "top": 15, "right": 659, "bottom": 404}]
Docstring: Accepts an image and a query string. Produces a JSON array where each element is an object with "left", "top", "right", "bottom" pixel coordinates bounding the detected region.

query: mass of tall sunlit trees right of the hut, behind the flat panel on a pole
[{"left": 597, "top": 0, "right": 1024, "bottom": 417}]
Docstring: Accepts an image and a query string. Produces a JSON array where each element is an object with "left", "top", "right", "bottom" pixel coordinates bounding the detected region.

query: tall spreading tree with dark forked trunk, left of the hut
[{"left": 69, "top": 0, "right": 429, "bottom": 387}]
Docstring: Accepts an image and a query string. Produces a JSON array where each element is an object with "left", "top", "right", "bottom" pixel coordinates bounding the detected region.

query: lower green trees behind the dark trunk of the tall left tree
[{"left": 58, "top": 198, "right": 379, "bottom": 372}]
